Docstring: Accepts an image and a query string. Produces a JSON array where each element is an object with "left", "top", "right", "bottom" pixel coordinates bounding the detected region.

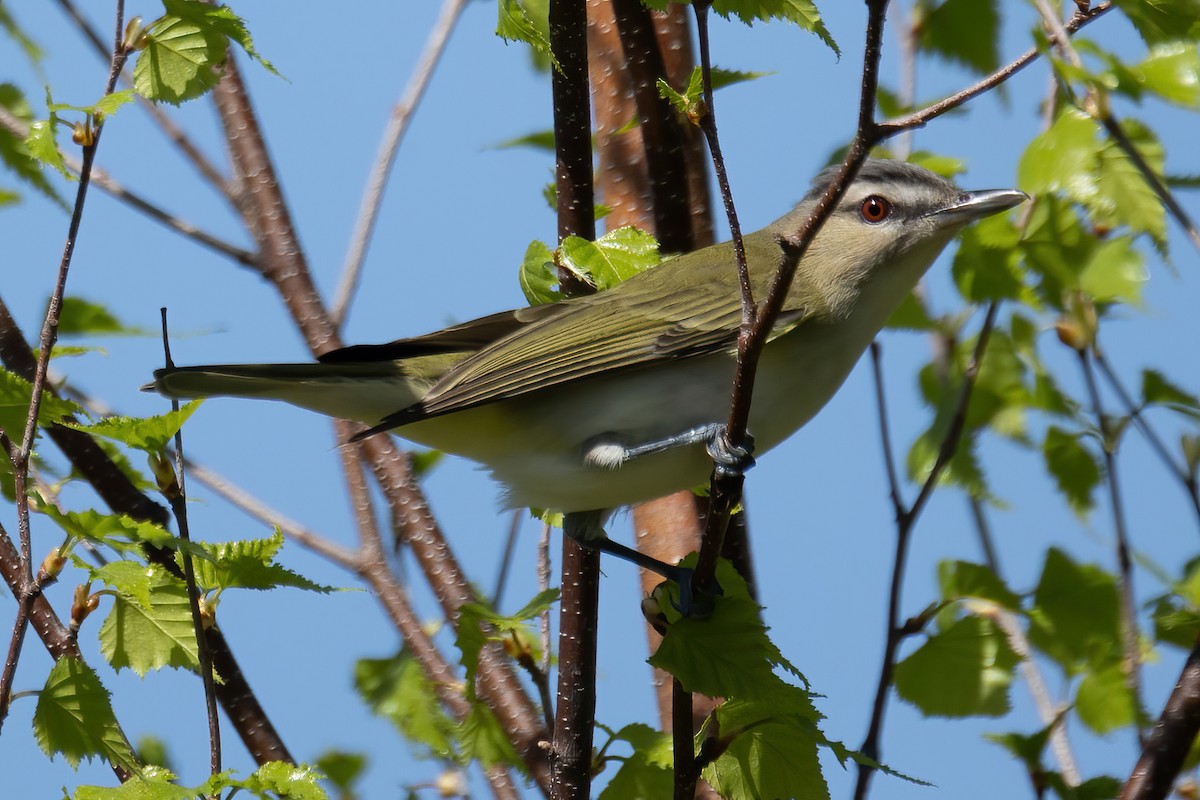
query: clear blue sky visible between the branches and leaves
[{"left": 0, "top": 0, "right": 1200, "bottom": 799}]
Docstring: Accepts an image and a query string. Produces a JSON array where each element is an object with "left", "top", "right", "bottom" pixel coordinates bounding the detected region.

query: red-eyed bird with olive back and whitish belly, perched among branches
[{"left": 148, "top": 161, "right": 1026, "bottom": 532}]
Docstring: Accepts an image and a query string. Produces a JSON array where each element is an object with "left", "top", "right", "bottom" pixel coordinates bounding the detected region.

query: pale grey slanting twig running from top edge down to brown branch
[{"left": 330, "top": 0, "right": 467, "bottom": 327}]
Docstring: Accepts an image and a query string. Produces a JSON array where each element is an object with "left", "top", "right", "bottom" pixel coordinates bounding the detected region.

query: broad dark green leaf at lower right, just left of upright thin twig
[{"left": 1030, "top": 547, "right": 1122, "bottom": 673}]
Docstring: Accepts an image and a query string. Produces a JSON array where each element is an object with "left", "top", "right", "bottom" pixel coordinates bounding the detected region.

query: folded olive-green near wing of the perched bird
[{"left": 362, "top": 235, "right": 805, "bottom": 432}]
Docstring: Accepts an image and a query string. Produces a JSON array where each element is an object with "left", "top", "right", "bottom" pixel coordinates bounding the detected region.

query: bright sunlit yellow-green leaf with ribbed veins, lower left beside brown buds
[{"left": 100, "top": 565, "right": 199, "bottom": 676}]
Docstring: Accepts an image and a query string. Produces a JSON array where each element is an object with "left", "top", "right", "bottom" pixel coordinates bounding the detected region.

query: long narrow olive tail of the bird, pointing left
[{"left": 142, "top": 361, "right": 428, "bottom": 425}]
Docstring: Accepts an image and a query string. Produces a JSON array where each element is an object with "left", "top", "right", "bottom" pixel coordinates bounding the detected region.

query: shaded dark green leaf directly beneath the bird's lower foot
[{"left": 649, "top": 561, "right": 803, "bottom": 699}]
